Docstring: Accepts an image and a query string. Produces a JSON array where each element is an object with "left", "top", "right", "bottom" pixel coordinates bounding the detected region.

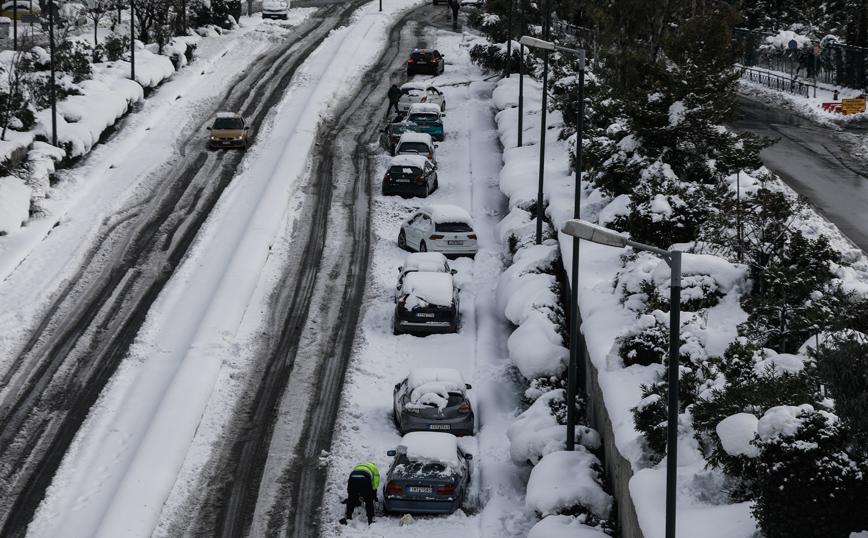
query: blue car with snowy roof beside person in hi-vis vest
[{"left": 383, "top": 432, "right": 473, "bottom": 514}]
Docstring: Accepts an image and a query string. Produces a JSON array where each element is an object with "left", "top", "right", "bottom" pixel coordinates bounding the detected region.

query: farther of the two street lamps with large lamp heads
[{"left": 519, "top": 36, "right": 585, "bottom": 451}]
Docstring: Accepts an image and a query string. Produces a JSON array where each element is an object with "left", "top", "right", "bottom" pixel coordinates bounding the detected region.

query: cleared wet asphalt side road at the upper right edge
[{"left": 728, "top": 98, "right": 868, "bottom": 252}]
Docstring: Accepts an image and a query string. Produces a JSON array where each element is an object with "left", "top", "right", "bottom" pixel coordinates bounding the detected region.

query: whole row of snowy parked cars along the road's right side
[{"left": 380, "top": 54, "right": 477, "bottom": 514}]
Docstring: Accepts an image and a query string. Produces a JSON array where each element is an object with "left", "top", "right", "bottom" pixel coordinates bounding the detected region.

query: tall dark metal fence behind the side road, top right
[{"left": 734, "top": 28, "right": 868, "bottom": 90}]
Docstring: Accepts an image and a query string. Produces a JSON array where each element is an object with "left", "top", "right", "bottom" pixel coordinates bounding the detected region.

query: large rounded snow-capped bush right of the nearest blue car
[{"left": 526, "top": 446, "right": 612, "bottom": 519}]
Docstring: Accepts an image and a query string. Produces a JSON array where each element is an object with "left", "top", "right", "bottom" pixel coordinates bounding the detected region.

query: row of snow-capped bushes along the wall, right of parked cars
[{"left": 493, "top": 77, "right": 612, "bottom": 538}]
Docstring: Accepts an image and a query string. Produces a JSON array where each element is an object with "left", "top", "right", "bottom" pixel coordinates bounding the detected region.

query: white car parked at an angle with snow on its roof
[{"left": 398, "top": 204, "right": 477, "bottom": 256}]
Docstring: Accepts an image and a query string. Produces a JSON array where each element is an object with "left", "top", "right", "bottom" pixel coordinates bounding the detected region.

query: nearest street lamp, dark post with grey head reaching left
[{"left": 562, "top": 219, "right": 681, "bottom": 538}]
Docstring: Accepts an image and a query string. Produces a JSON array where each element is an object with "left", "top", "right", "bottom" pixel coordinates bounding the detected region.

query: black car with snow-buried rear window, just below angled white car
[{"left": 393, "top": 272, "right": 460, "bottom": 335}]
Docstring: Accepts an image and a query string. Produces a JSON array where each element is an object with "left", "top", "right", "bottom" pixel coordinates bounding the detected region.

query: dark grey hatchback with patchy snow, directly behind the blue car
[{"left": 392, "top": 368, "right": 473, "bottom": 436}]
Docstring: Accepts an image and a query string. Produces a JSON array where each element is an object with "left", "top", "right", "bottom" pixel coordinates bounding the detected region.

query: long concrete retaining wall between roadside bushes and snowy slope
[{"left": 579, "top": 346, "right": 644, "bottom": 538}]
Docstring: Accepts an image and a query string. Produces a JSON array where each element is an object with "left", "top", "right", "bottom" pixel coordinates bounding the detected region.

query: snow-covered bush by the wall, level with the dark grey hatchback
[{"left": 506, "top": 389, "right": 602, "bottom": 465}]
